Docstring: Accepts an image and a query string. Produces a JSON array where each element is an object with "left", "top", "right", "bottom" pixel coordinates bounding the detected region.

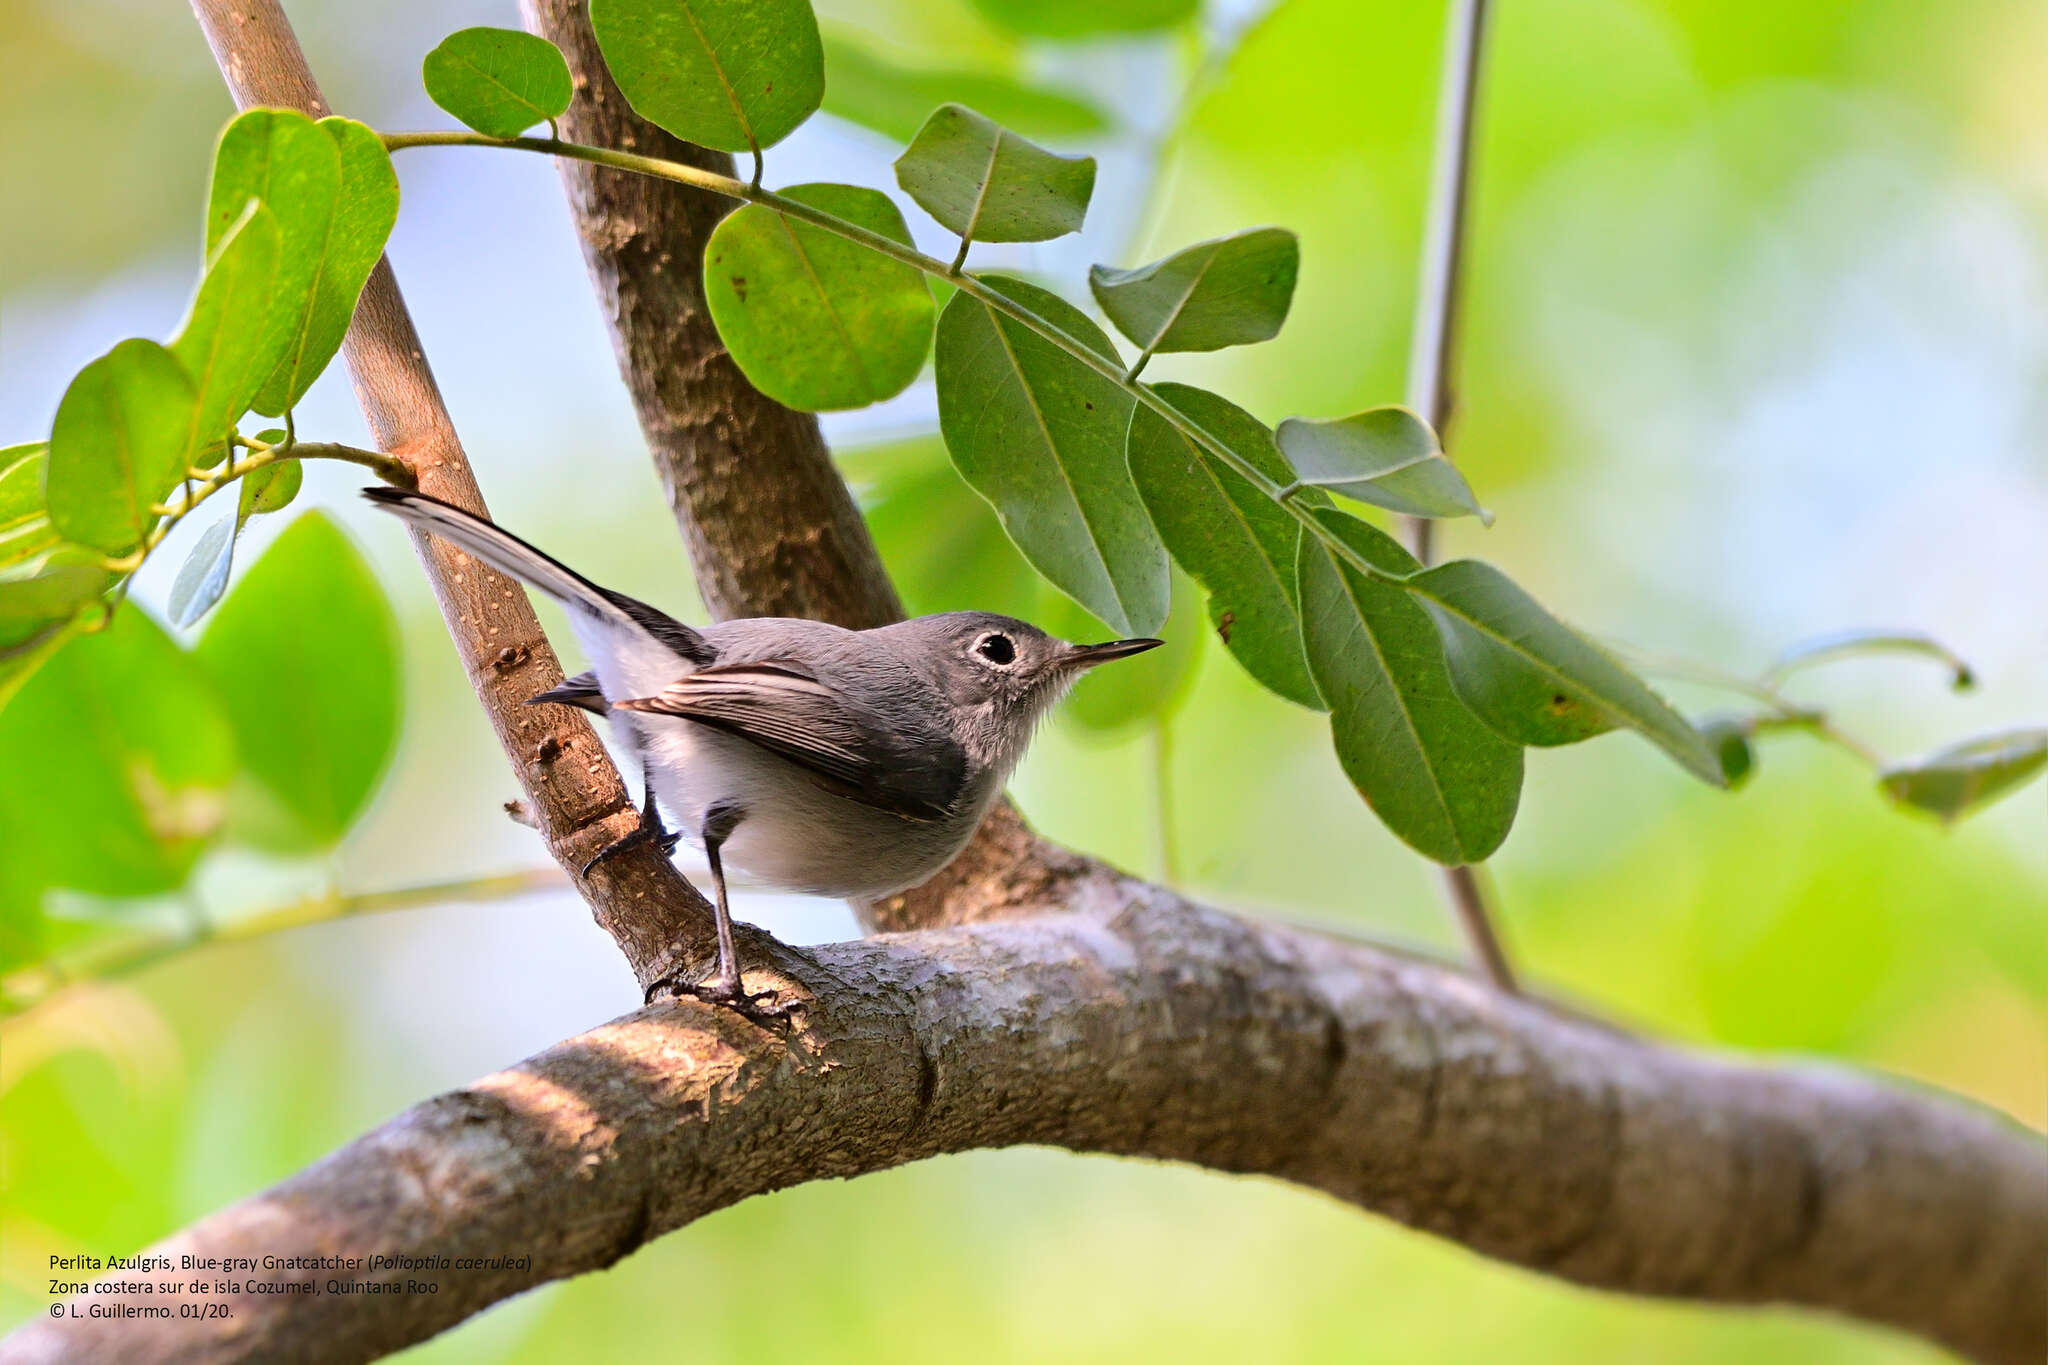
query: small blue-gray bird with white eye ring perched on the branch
[{"left": 362, "top": 487, "right": 1159, "bottom": 1001}]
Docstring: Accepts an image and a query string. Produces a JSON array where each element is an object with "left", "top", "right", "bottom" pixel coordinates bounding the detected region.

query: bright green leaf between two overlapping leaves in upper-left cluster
[{"left": 207, "top": 108, "right": 342, "bottom": 415}]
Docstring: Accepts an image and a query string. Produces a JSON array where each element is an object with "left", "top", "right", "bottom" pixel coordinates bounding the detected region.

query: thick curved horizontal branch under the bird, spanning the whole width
[{"left": 0, "top": 864, "right": 2048, "bottom": 1365}]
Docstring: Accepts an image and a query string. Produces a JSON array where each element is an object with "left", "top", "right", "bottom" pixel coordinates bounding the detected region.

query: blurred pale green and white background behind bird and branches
[{"left": 0, "top": 0, "right": 2048, "bottom": 1363}]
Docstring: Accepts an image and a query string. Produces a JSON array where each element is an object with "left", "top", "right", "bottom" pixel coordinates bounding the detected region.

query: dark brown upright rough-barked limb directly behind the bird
[{"left": 520, "top": 0, "right": 1055, "bottom": 929}]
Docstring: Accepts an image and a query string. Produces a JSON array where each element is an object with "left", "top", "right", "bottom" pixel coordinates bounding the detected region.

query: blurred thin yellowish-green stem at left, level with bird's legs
[{"left": 0, "top": 868, "right": 567, "bottom": 1015}]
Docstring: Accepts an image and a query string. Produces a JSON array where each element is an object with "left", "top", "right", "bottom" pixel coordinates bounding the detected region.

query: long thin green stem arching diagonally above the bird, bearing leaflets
[{"left": 383, "top": 129, "right": 1403, "bottom": 583}]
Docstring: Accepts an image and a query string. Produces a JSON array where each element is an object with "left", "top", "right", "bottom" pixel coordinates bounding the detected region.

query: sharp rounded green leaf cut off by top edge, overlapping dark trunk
[{"left": 590, "top": 0, "right": 825, "bottom": 151}]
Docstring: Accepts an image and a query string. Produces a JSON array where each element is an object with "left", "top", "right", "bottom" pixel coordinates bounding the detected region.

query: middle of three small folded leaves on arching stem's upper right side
[{"left": 1087, "top": 227, "right": 1300, "bottom": 352}]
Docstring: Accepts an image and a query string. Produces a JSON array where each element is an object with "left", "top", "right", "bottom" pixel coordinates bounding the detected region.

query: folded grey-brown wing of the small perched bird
[{"left": 612, "top": 659, "right": 967, "bottom": 821}]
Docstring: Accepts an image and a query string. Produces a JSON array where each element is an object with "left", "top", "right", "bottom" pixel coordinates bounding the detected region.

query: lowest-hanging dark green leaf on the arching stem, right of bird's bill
[{"left": 1298, "top": 508, "right": 1522, "bottom": 864}]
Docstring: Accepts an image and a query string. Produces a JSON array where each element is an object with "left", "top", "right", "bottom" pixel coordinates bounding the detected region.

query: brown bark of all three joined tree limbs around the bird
[{"left": 19, "top": 10, "right": 2048, "bottom": 1365}]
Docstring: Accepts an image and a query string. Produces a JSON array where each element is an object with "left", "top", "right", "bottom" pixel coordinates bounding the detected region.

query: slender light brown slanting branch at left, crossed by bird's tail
[{"left": 193, "top": 0, "right": 711, "bottom": 986}]
